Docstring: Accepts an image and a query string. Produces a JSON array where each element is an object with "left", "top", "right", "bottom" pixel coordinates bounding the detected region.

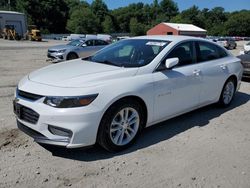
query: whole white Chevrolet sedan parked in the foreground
[{"left": 14, "top": 36, "right": 242, "bottom": 151}]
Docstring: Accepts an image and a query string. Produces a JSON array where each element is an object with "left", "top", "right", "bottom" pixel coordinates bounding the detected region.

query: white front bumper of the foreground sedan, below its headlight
[{"left": 15, "top": 92, "right": 102, "bottom": 148}]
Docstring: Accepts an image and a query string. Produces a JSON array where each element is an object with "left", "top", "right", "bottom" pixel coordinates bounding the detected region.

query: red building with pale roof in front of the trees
[{"left": 147, "top": 22, "right": 207, "bottom": 37}]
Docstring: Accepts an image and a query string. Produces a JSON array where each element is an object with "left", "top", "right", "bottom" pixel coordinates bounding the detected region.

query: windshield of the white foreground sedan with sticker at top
[{"left": 87, "top": 39, "right": 170, "bottom": 67}]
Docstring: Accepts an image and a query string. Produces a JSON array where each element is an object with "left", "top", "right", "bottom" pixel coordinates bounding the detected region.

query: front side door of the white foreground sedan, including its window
[{"left": 153, "top": 42, "right": 201, "bottom": 121}]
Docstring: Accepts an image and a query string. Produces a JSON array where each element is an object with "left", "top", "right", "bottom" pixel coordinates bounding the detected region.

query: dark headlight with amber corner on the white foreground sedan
[{"left": 44, "top": 94, "right": 98, "bottom": 108}]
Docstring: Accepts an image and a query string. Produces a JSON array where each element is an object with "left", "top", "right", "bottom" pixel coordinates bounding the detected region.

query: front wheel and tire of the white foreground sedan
[{"left": 97, "top": 99, "right": 145, "bottom": 152}]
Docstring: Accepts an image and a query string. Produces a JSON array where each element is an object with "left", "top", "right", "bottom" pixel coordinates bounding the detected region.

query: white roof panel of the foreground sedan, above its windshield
[{"left": 133, "top": 35, "right": 207, "bottom": 42}]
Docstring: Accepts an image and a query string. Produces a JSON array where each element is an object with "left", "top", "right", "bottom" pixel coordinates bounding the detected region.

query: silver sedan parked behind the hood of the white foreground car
[{"left": 47, "top": 39, "right": 108, "bottom": 62}]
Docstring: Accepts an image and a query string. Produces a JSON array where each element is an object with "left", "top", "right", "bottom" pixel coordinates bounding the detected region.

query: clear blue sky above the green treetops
[{"left": 87, "top": 0, "right": 250, "bottom": 12}]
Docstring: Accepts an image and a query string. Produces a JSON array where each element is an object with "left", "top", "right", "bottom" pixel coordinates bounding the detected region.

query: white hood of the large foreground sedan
[{"left": 28, "top": 59, "right": 138, "bottom": 88}]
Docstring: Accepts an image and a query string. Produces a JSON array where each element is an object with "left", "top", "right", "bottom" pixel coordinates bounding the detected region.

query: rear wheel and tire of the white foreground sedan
[{"left": 219, "top": 78, "right": 236, "bottom": 107}]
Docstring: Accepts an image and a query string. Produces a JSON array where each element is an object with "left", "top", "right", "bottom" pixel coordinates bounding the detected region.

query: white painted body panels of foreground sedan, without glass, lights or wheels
[{"left": 15, "top": 36, "right": 242, "bottom": 148}]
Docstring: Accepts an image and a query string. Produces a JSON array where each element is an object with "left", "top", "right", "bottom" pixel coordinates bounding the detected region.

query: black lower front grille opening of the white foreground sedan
[{"left": 20, "top": 106, "right": 39, "bottom": 124}]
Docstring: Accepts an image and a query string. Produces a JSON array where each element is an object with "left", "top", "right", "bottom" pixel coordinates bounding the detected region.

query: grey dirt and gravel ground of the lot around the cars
[{"left": 0, "top": 39, "right": 250, "bottom": 188}]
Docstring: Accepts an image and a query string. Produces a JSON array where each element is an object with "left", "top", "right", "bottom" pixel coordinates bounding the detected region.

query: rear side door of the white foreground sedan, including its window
[{"left": 195, "top": 41, "right": 230, "bottom": 104}]
